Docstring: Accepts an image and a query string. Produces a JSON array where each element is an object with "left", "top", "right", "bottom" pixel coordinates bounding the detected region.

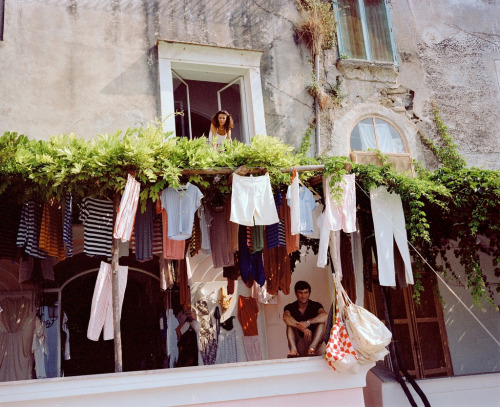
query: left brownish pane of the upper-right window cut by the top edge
[{"left": 338, "top": 0, "right": 366, "bottom": 59}]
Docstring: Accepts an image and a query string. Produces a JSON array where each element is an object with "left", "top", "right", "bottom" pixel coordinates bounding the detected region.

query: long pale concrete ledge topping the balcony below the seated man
[{"left": 0, "top": 357, "right": 373, "bottom": 407}]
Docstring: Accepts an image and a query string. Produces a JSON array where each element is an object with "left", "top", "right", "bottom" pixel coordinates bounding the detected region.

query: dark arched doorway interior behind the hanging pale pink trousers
[{"left": 62, "top": 270, "right": 164, "bottom": 376}]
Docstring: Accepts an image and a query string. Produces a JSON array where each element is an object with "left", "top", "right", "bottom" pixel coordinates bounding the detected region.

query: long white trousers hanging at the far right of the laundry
[{"left": 370, "top": 186, "right": 413, "bottom": 287}]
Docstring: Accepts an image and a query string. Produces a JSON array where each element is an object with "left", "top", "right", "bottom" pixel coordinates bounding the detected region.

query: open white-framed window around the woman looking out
[{"left": 158, "top": 40, "right": 266, "bottom": 143}]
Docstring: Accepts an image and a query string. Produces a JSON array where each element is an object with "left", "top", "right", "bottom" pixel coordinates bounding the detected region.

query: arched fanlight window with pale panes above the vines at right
[{"left": 351, "top": 116, "right": 409, "bottom": 153}]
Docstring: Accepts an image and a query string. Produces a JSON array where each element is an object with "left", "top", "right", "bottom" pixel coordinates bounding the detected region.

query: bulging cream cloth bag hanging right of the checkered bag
[{"left": 336, "top": 278, "right": 392, "bottom": 362}]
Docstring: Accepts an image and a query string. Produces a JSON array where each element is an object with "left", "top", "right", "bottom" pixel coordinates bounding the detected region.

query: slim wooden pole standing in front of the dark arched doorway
[{"left": 111, "top": 193, "right": 123, "bottom": 372}]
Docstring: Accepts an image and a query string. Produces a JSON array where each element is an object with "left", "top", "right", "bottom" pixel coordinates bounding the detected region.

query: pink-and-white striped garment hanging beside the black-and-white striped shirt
[{"left": 114, "top": 174, "right": 141, "bottom": 242}]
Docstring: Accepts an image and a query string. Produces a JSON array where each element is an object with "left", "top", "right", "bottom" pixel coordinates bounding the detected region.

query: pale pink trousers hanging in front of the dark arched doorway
[{"left": 87, "top": 262, "right": 128, "bottom": 341}]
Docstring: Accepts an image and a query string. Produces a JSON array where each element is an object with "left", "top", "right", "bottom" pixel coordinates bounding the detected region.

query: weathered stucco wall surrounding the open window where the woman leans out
[{"left": 0, "top": 0, "right": 312, "bottom": 143}]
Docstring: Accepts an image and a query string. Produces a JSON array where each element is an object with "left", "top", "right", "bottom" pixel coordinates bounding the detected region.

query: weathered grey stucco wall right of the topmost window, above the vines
[{"left": 390, "top": 0, "right": 500, "bottom": 168}]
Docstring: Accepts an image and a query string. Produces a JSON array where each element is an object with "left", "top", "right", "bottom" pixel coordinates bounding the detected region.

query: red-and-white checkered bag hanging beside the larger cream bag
[{"left": 325, "top": 297, "right": 358, "bottom": 373}]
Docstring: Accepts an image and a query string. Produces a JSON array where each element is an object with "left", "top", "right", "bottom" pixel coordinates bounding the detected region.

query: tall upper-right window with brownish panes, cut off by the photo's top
[{"left": 333, "top": 0, "right": 397, "bottom": 63}]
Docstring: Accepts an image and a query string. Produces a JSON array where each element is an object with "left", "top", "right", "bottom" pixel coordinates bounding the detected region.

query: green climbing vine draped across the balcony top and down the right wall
[{"left": 0, "top": 113, "right": 500, "bottom": 305}]
